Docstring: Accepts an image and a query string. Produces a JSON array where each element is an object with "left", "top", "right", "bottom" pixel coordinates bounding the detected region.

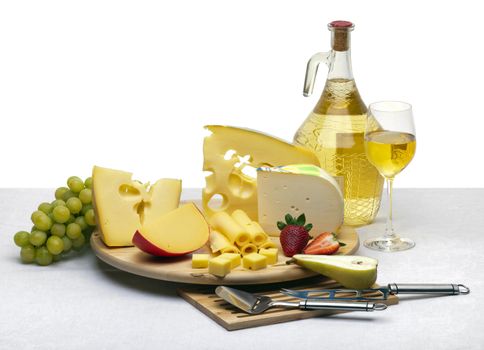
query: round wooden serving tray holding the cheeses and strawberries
[{"left": 91, "top": 227, "right": 359, "bottom": 285}]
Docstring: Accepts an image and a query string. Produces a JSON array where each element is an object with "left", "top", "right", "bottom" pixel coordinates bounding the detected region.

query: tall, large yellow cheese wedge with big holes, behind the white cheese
[{"left": 202, "top": 125, "right": 319, "bottom": 221}]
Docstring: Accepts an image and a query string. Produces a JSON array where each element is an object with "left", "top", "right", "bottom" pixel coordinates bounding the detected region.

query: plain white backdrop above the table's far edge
[{"left": 0, "top": 0, "right": 484, "bottom": 187}]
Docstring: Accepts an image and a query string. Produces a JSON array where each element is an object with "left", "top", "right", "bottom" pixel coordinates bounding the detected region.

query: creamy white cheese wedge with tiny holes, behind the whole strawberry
[{"left": 257, "top": 164, "right": 344, "bottom": 236}]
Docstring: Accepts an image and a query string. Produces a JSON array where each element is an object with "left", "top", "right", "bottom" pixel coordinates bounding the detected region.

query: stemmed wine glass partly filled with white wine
[{"left": 364, "top": 101, "right": 416, "bottom": 252}]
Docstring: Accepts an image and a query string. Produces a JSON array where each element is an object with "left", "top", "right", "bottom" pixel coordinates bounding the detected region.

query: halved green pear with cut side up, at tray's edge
[{"left": 288, "top": 254, "right": 378, "bottom": 289}]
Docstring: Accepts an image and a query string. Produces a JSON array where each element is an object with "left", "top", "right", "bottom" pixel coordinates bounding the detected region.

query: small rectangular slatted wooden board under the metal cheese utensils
[{"left": 177, "top": 277, "right": 398, "bottom": 331}]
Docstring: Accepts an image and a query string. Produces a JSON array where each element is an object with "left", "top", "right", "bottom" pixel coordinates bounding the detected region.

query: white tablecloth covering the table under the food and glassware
[{"left": 0, "top": 189, "right": 484, "bottom": 350}]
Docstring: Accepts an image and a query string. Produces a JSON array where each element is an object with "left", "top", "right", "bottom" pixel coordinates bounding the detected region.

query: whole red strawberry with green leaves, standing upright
[{"left": 277, "top": 214, "right": 313, "bottom": 256}]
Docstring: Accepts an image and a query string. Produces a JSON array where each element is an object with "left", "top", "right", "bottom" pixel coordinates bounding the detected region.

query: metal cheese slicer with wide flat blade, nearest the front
[{"left": 215, "top": 286, "right": 387, "bottom": 315}]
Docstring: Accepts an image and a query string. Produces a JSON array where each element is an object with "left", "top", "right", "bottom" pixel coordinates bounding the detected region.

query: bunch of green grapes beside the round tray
[{"left": 14, "top": 176, "right": 96, "bottom": 266}]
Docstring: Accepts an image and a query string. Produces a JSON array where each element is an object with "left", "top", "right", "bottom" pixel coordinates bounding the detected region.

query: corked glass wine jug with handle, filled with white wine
[{"left": 294, "top": 21, "right": 383, "bottom": 226}]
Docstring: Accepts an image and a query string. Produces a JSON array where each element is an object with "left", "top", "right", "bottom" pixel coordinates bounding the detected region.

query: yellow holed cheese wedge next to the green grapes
[{"left": 92, "top": 166, "right": 181, "bottom": 247}]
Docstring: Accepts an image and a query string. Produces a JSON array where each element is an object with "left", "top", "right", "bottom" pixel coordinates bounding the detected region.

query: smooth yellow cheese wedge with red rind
[{"left": 133, "top": 203, "right": 210, "bottom": 256}]
